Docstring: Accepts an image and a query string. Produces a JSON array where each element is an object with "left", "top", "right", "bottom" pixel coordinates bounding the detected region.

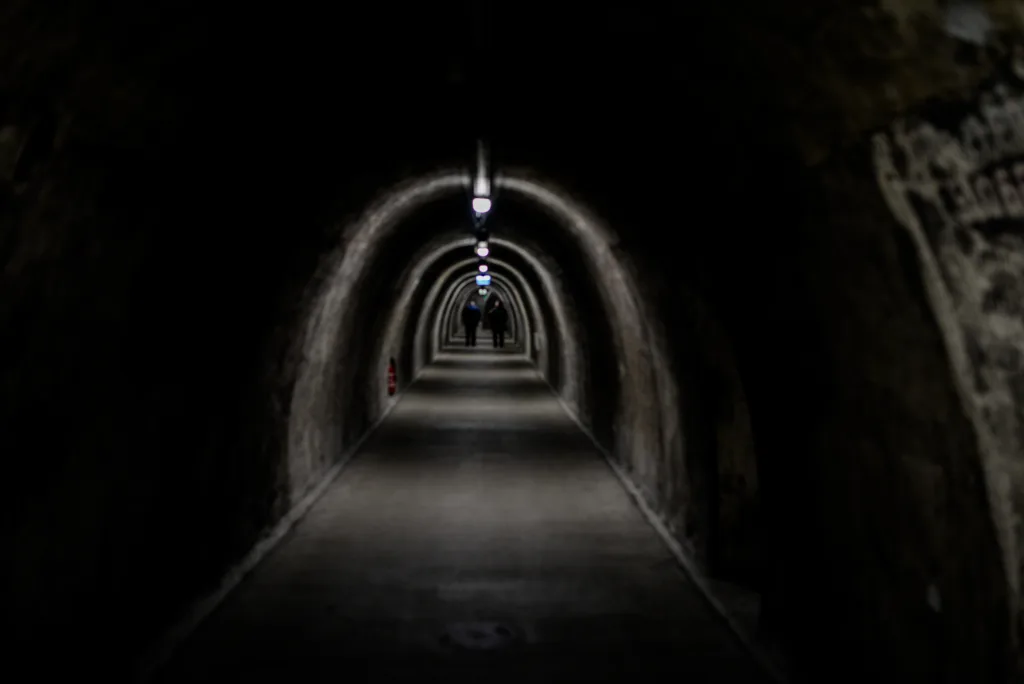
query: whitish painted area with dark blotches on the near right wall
[{"left": 873, "top": 74, "right": 1024, "bottom": 619}]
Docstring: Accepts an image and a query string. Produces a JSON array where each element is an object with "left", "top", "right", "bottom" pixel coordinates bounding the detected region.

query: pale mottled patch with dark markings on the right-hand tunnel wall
[{"left": 871, "top": 52, "right": 1024, "bottom": 585}]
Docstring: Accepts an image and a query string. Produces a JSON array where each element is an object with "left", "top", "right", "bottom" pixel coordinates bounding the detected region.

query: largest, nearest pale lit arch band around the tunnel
[{"left": 289, "top": 167, "right": 679, "bottom": 516}]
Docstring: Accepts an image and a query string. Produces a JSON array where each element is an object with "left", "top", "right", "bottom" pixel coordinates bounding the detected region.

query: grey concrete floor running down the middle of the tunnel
[{"left": 159, "top": 348, "right": 767, "bottom": 684}]
